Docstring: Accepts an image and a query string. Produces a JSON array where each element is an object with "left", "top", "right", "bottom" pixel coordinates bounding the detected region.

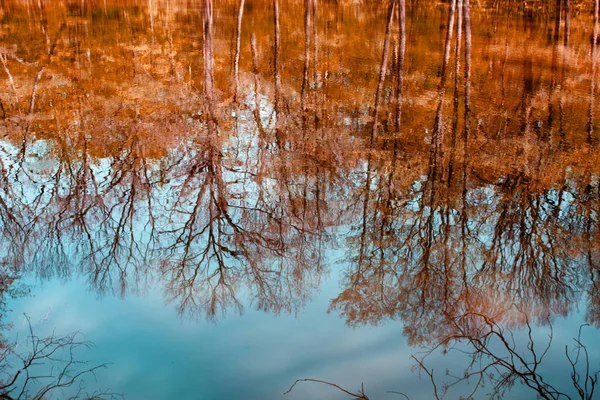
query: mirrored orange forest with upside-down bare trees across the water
[{"left": 0, "top": 0, "right": 600, "bottom": 396}]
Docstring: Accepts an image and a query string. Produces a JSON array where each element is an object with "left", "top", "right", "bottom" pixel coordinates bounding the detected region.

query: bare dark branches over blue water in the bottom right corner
[{"left": 413, "top": 307, "right": 600, "bottom": 400}]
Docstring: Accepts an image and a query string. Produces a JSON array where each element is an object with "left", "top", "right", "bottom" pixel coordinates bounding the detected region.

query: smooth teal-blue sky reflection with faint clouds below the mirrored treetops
[{"left": 4, "top": 262, "right": 600, "bottom": 399}]
